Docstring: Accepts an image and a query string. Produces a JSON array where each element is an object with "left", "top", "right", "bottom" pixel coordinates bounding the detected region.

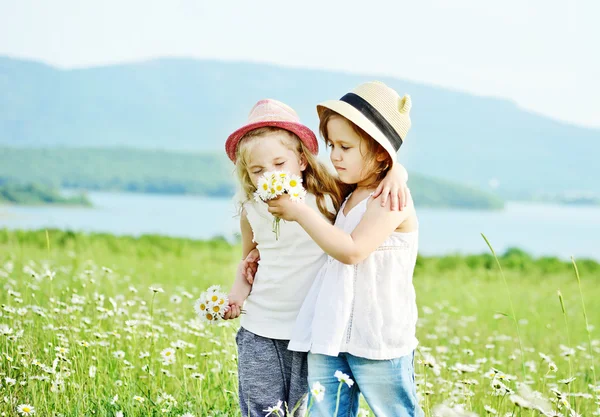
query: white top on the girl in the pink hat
[{"left": 240, "top": 194, "right": 335, "bottom": 340}]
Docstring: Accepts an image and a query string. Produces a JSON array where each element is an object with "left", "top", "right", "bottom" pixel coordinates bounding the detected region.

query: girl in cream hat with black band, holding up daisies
[{"left": 269, "top": 82, "right": 422, "bottom": 417}]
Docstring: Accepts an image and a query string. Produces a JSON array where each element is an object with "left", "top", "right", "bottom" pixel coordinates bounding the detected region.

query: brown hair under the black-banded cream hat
[{"left": 319, "top": 108, "right": 393, "bottom": 184}]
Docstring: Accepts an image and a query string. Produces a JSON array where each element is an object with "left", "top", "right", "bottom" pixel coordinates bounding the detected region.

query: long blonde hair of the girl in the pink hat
[{"left": 235, "top": 126, "right": 346, "bottom": 222}]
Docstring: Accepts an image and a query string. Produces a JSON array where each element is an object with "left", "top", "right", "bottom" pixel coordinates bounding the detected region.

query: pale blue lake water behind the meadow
[{"left": 0, "top": 192, "right": 600, "bottom": 260}]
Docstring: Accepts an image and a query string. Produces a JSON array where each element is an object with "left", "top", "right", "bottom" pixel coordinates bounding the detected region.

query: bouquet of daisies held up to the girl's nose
[{"left": 254, "top": 171, "right": 306, "bottom": 240}]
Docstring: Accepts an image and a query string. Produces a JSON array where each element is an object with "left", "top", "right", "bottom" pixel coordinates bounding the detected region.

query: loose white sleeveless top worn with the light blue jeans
[{"left": 288, "top": 196, "right": 418, "bottom": 359}]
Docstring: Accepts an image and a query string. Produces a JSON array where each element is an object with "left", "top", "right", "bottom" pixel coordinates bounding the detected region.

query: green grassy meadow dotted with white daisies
[{"left": 0, "top": 230, "right": 600, "bottom": 416}]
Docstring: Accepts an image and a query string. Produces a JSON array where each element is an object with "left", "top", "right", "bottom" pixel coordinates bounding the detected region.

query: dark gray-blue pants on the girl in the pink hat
[{"left": 235, "top": 327, "right": 308, "bottom": 417}]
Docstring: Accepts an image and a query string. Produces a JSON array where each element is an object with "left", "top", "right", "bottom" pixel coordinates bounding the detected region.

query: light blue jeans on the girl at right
[{"left": 308, "top": 352, "right": 423, "bottom": 417}]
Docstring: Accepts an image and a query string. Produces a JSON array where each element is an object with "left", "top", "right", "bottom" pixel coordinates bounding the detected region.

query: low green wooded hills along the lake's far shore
[{"left": 0, "top": 147, "right": 504, "bottom": 209}]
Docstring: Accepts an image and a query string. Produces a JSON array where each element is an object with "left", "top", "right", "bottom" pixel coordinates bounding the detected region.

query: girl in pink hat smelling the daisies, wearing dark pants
[{"left": 225, "top": 100, "right": 406, "bottom": 417}]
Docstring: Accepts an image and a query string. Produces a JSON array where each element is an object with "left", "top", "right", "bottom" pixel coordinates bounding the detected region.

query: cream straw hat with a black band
[{"left": 317, "top": 81, "right": 411, "bottom": 162}]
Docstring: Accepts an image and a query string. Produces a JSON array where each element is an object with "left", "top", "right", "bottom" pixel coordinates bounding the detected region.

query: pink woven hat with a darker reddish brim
[{"left": 225, "top": 99, "right": 319, "bottom": 163}]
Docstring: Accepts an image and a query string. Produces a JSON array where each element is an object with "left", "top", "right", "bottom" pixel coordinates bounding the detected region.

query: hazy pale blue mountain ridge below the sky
[{"left": 0, "top": 57, "right": 600, "bottom": 197}]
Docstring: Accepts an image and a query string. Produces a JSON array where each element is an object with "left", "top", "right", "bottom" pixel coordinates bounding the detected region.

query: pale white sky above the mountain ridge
[{"left": 0, "top": 0, "right": 600, "bottom": 128}]
